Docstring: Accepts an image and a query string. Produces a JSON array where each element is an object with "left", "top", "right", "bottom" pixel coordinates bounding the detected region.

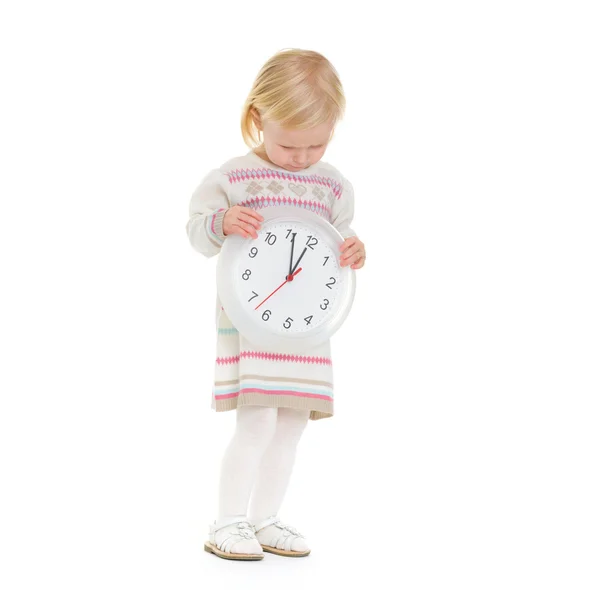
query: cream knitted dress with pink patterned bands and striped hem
[{"left": 186, "top": 151, "right": 356, "bottom": 420}]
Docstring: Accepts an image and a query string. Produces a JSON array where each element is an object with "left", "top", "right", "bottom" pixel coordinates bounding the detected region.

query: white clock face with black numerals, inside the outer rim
[{"left": 235, "top": 220, "right": 344, "bottom": 335}]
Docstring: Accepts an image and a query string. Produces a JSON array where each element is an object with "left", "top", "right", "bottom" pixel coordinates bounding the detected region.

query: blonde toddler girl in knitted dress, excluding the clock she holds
[{"left": 186, "top": 49, "right": 365, "bottom": 560}]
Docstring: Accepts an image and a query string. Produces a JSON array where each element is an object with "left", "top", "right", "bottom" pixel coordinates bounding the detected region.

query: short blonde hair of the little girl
[{"left": 242, "top": 49, "right": 346, "bottom": 148}]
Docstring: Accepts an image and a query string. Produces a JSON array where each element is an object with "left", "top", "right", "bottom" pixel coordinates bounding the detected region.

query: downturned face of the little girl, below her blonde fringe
[{"left": 262, "top": 121, "right": 333, "bottom": 172}]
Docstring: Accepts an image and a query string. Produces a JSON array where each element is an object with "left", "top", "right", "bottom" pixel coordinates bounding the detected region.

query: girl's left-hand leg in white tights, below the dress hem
[{"left": 219, "top": 406, "right": 277, "bottom": 522}]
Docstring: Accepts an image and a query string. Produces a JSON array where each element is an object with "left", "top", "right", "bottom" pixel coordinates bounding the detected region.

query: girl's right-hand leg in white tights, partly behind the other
[{"left": 248, "top": 408, "right": 310, "bottom": 524}]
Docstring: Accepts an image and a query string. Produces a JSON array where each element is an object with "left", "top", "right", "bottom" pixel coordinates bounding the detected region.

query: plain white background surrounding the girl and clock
[{"left": 0, "top": 0, "right": 600, "bottom": 590}]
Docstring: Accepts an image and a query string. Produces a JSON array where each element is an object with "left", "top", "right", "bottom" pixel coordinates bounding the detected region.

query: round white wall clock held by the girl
[{"left": 217, "top": 206, "right": 355, "bottom": 352}]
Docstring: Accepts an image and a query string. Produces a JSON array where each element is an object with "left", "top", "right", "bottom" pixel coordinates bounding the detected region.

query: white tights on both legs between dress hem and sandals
[{"left": 218, "top": 406, "right": 310, "bottom": 524}]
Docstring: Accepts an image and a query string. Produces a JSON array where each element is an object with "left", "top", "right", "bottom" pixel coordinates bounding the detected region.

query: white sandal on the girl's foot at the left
[{"left": 204, "top": 517, "right": 265, "bottom": 561}]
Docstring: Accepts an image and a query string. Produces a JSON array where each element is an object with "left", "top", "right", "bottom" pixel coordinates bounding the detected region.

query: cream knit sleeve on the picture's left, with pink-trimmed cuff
[{"left": 185, "top": 168, "right": 230, "bottom": 258}]
